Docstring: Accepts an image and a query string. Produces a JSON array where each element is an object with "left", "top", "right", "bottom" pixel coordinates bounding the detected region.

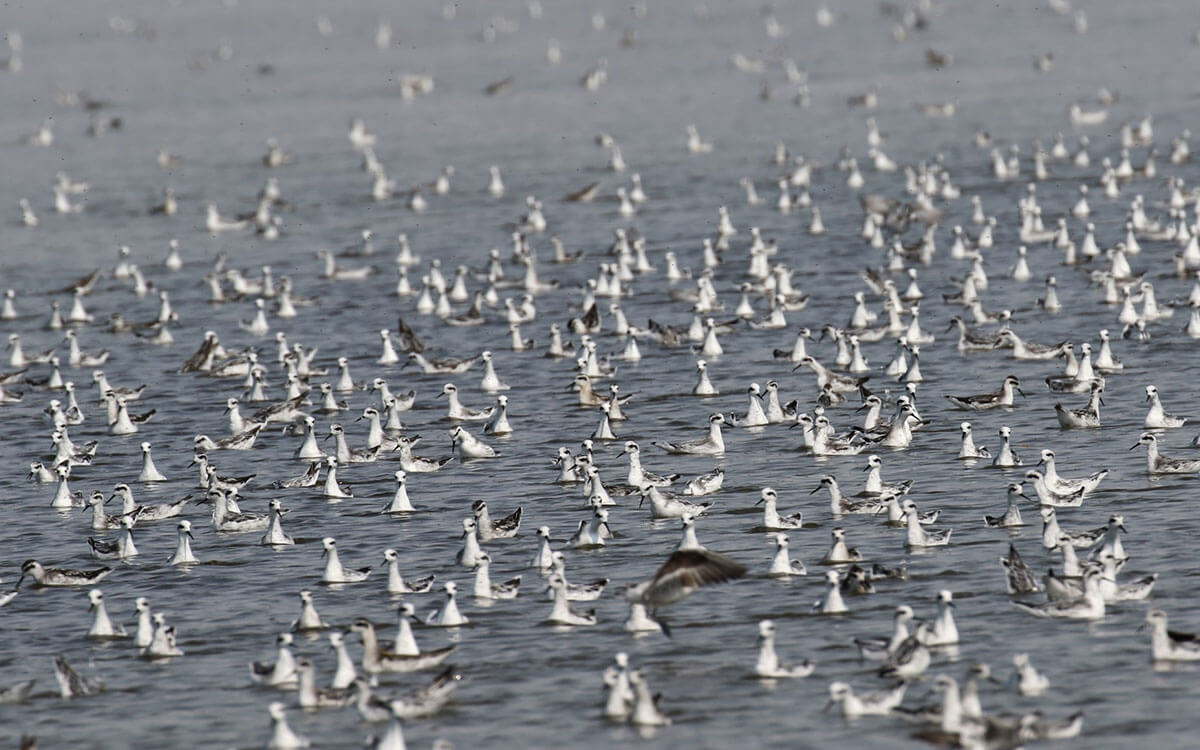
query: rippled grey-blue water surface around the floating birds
[{"left": 0, "top": 1, "right": 1200, "bottom": 748}]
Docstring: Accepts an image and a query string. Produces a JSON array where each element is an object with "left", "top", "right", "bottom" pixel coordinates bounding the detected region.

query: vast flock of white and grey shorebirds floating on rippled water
[{"left": 0, "top": 4, "right": 1200, "bottom": 750}]
